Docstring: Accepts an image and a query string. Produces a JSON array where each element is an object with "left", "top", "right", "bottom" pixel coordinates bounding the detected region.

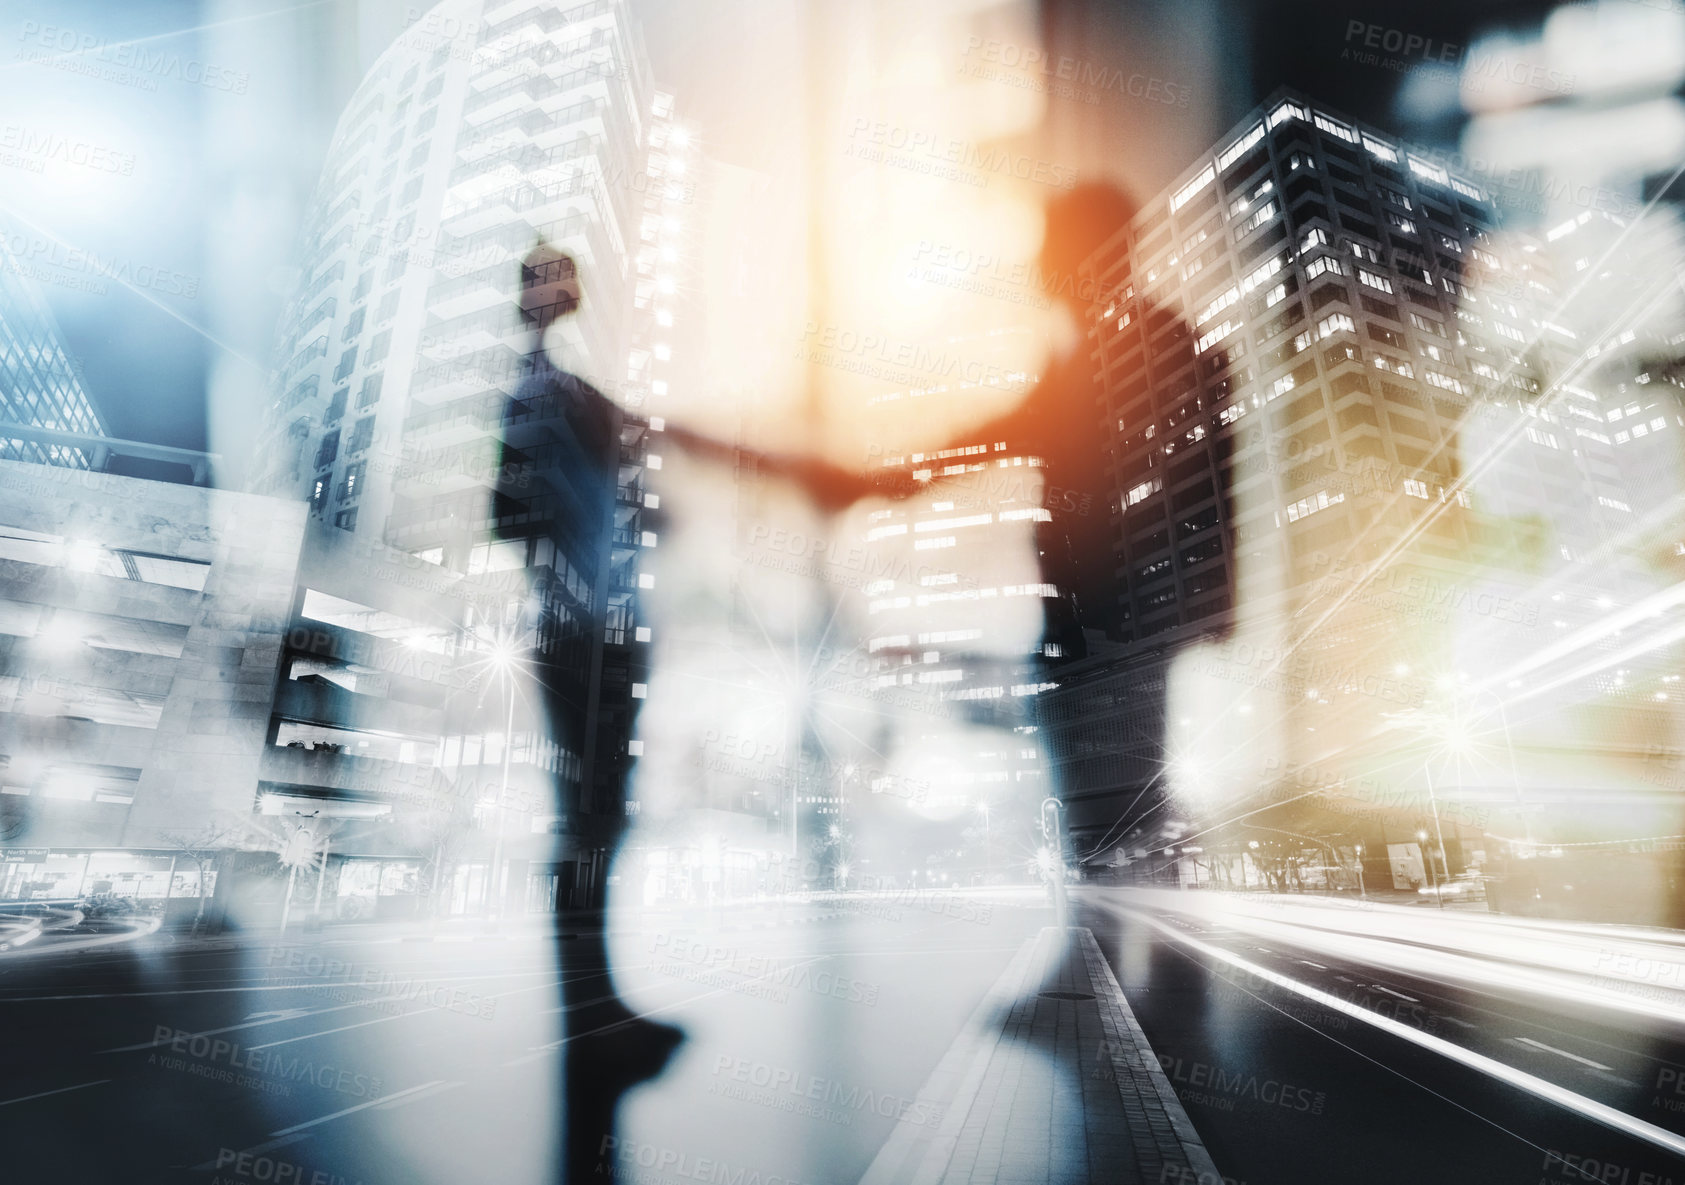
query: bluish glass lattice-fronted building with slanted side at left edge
[{"left": 0, "top": 236, "right": 106, "bottom": 469}]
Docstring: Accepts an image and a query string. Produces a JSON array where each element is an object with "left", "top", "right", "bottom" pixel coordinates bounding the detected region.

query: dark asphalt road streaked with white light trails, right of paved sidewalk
[{"left": 1075, "top": 888, "right": 1685, "bottom": 1185}]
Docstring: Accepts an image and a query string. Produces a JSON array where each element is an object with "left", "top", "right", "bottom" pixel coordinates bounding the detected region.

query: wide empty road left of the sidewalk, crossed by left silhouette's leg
[{"left": 0, "top": 895, "right": 1048, "bottom": 1185}]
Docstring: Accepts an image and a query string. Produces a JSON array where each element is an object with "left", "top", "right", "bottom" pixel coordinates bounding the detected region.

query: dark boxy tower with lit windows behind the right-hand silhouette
[{"left": 1043, "top": 91, "right": 1668, "bottom": 871}]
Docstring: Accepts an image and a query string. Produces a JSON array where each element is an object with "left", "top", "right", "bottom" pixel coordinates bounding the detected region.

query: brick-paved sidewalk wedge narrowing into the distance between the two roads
[{"left": 861, "top": 927, "right": 1222, "bottom": 1185}]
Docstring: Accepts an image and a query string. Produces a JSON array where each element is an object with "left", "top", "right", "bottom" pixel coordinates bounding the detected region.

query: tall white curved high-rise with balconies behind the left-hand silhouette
[{"left": 242, "top": 0, "right": 691, "bottom": 909}]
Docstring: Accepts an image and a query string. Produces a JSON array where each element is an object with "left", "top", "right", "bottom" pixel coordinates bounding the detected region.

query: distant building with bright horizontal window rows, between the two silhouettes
[{"left": 861, "top": 329, "right": 1080, "bottom": 878}]
